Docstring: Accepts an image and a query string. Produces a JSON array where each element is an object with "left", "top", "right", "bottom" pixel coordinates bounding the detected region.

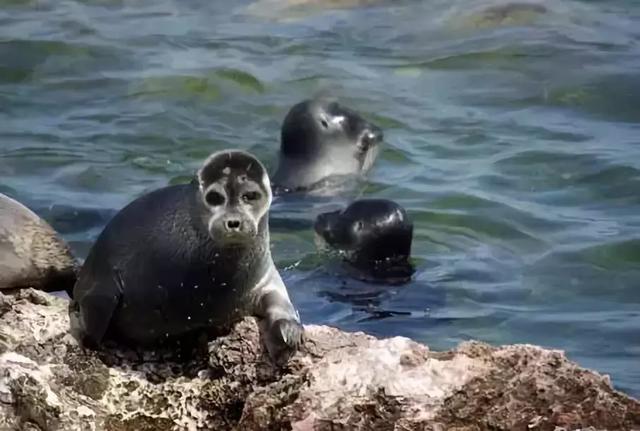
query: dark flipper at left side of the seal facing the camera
[{"left": 69, "top": 271, "right": 122, "bottom": 349}]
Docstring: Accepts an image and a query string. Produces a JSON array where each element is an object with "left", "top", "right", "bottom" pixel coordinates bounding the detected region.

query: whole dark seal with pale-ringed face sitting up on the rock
[{"left": 69, "top": 150, "right": 303, "bottom": 365}]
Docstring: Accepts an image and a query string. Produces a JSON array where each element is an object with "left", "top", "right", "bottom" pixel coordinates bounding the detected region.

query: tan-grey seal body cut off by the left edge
[{"left": 0, "top": 193, "right": 78, "bottom": 292}]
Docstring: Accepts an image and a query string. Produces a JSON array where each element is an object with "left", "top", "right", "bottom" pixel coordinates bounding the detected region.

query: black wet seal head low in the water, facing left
[{"left": 314, "top": 199, "right": 414, "bottom": 284}]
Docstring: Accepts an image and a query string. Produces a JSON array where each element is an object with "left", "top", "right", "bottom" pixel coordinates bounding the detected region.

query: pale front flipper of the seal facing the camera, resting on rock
[{"left": 254, "top": 268, "right": 304, "bottom": 367}]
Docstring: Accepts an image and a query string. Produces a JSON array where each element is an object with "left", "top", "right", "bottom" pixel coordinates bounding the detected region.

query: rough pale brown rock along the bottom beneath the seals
[{"left": 0, "top": 290, "right": 640, "bottom": 431}]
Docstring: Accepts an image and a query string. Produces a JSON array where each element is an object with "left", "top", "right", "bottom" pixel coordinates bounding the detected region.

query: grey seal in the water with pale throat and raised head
[{"left": 273, "top": 98, "right": 383, "bottom": 194}]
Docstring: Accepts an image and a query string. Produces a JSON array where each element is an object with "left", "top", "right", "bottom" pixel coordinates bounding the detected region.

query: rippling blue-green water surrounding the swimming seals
[{"left": 0, "top": 0, "right": 640, "bottom": 396}]
